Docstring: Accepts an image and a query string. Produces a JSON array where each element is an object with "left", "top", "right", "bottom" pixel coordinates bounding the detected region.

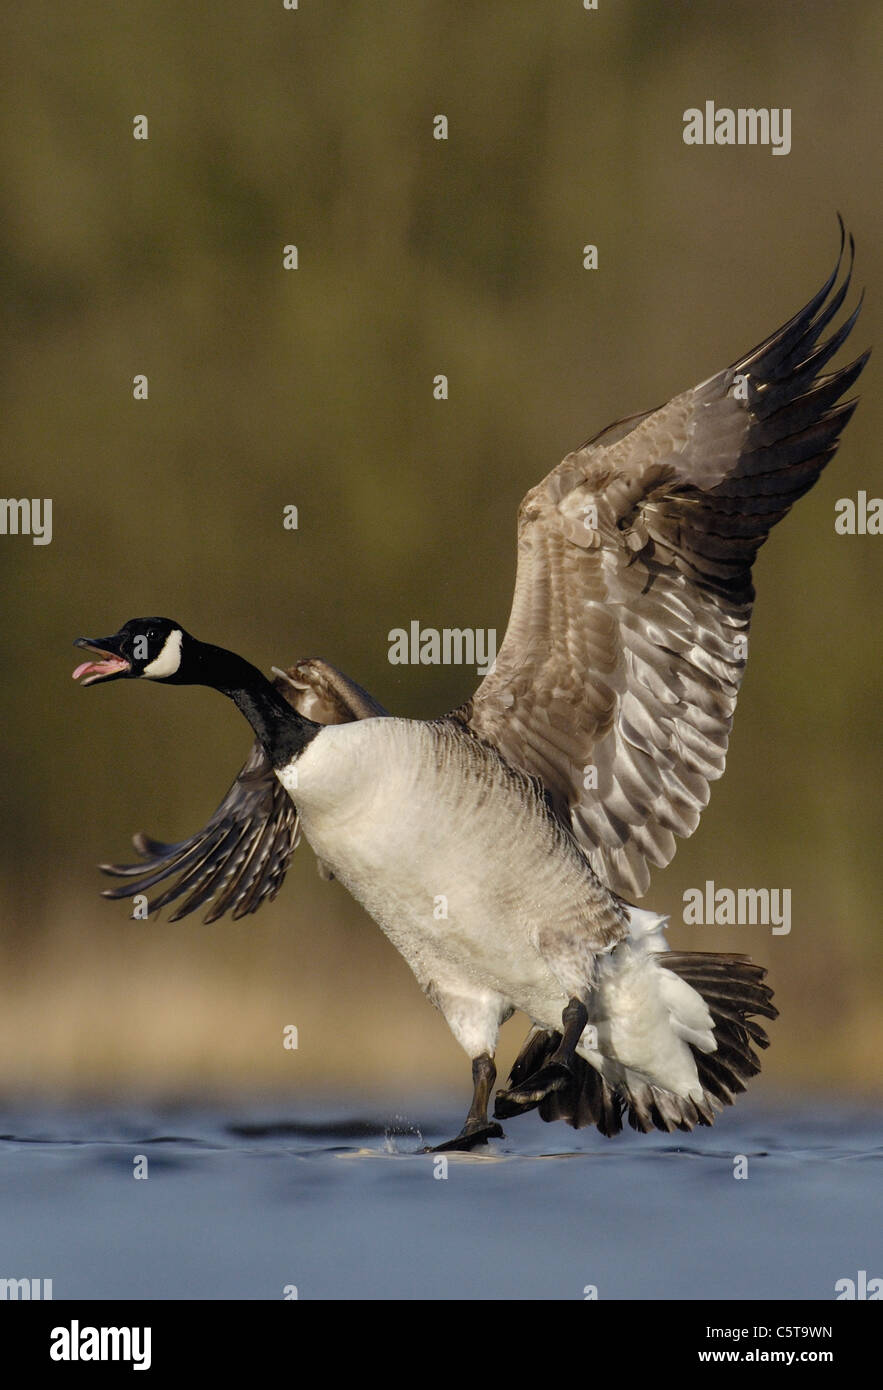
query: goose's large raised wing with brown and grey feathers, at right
[{"left": 452, "top": 224, "right": 868, "bottom": 897}]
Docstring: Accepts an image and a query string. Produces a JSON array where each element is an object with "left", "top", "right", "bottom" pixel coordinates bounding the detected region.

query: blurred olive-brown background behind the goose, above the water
[{"left": 0, "top": 0, "right": 883, "bottom": 1105}]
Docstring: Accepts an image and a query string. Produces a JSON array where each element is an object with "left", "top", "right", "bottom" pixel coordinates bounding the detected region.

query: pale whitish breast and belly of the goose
[{"left": 281, "top": 719, "right": 625, "bottom": 1027}]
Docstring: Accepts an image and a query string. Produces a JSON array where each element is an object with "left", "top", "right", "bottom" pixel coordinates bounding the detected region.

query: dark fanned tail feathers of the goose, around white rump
[{"left": 508, "top": 951, "right": 779, "bottom": 1137}]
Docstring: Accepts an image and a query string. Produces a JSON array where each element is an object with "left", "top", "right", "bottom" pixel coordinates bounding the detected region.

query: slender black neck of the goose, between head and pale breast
[{"left": 185, "top": 642, "right": 323, "bottom": 767}]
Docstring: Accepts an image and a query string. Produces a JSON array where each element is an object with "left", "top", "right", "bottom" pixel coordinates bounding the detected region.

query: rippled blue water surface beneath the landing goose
[{"left": 0, "top": 1097, "right": 883, "bottom": 1300}]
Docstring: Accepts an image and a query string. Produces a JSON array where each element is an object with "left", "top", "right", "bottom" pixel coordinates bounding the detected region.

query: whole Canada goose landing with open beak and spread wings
[{"left": 74, "top": 233, "right": 868, "bottom": 1150}]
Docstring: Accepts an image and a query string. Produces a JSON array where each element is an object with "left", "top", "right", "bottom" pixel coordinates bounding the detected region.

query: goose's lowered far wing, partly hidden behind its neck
[{"left": 99, "top": 657, "right": 387, "bottom": 922}]
